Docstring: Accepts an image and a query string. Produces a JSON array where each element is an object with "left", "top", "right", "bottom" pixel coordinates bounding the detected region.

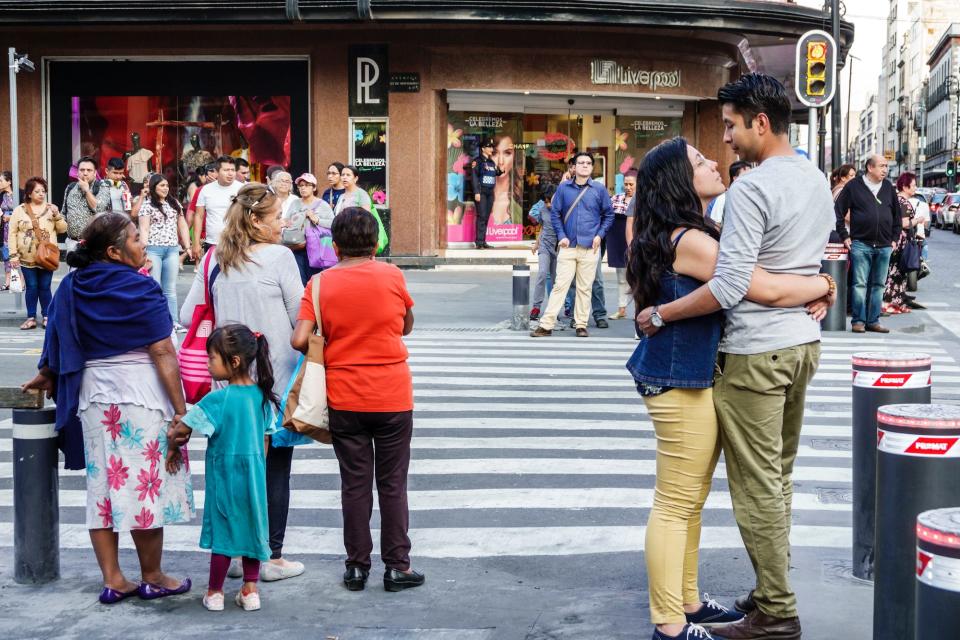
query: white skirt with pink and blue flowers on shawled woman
[{"left": 80, "top": 402, "right": 196, "bottom": 531}]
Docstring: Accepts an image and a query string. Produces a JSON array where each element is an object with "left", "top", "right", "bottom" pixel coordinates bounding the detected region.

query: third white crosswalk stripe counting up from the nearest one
[{"left": 0, "top": 458, "right": 852, "bottom": 482}]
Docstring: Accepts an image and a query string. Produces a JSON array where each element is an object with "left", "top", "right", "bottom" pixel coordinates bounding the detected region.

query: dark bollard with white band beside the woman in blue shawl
[{"left": 13, "top": 407, "right": 60, "bottom": 584}]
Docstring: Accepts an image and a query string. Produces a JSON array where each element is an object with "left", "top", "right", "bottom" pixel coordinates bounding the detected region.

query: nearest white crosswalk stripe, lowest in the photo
[{"left": 0, "top": 523, "right": 851, "bottom": 558}]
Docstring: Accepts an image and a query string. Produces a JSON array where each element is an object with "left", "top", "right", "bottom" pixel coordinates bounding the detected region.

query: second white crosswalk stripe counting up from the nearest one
[{"left": 0, "top": 487, "right": 852, "bottom": 512}]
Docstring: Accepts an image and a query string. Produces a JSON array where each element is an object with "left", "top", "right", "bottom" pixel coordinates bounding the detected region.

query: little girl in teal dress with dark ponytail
[{"left": 167, "top": 324, "right": 278, "bottom": 611}]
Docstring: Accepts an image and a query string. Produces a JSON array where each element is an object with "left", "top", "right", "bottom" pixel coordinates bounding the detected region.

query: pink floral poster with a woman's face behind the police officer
[{"left": 446, "top": 111, "right": 524, "bottom": 246}]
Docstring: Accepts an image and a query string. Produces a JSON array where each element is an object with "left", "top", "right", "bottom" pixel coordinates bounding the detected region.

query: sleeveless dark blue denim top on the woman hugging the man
[{"left": 627, "top": 271, "right": 723, "bottom": 389}]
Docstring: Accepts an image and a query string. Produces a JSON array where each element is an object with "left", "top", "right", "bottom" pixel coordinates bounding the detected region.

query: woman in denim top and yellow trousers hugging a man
[{"left": 627, "top": 138, "right": 829, "bottom": 640}]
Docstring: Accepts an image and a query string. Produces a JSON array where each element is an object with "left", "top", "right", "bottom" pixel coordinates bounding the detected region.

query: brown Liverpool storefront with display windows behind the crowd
[{"left": 0, "top": 3, "right": 852, "bottom": 256}]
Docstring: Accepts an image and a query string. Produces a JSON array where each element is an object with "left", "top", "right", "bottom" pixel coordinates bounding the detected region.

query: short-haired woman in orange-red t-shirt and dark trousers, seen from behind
[{"left": 290, "top": 207, "right": 425, "bottom": 591}]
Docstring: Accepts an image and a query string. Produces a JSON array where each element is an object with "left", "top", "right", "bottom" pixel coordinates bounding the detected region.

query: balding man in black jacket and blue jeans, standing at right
[{"left": 834, "top": 155, "right": 902, "bottom": 333}]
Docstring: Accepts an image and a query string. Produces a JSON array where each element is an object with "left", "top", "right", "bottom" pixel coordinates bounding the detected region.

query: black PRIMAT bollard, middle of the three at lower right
[{"left": 873, "top": 404, "right": 960, "bottom": 640}]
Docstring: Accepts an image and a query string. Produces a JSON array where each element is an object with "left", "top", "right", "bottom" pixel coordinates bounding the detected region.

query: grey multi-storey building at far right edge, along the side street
[{"left": 924, "top": 23, "right": 960, "bottom": 187}]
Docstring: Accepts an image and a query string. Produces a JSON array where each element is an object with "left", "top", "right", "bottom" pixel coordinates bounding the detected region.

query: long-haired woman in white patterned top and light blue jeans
[{"left": 138, "top": 173, "right": 193, "bottom": 332}]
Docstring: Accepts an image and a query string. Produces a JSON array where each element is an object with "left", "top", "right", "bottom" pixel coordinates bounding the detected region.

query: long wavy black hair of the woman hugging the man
[{"left": 627, "top": 137, "right": 720, "bottom": 309}]
